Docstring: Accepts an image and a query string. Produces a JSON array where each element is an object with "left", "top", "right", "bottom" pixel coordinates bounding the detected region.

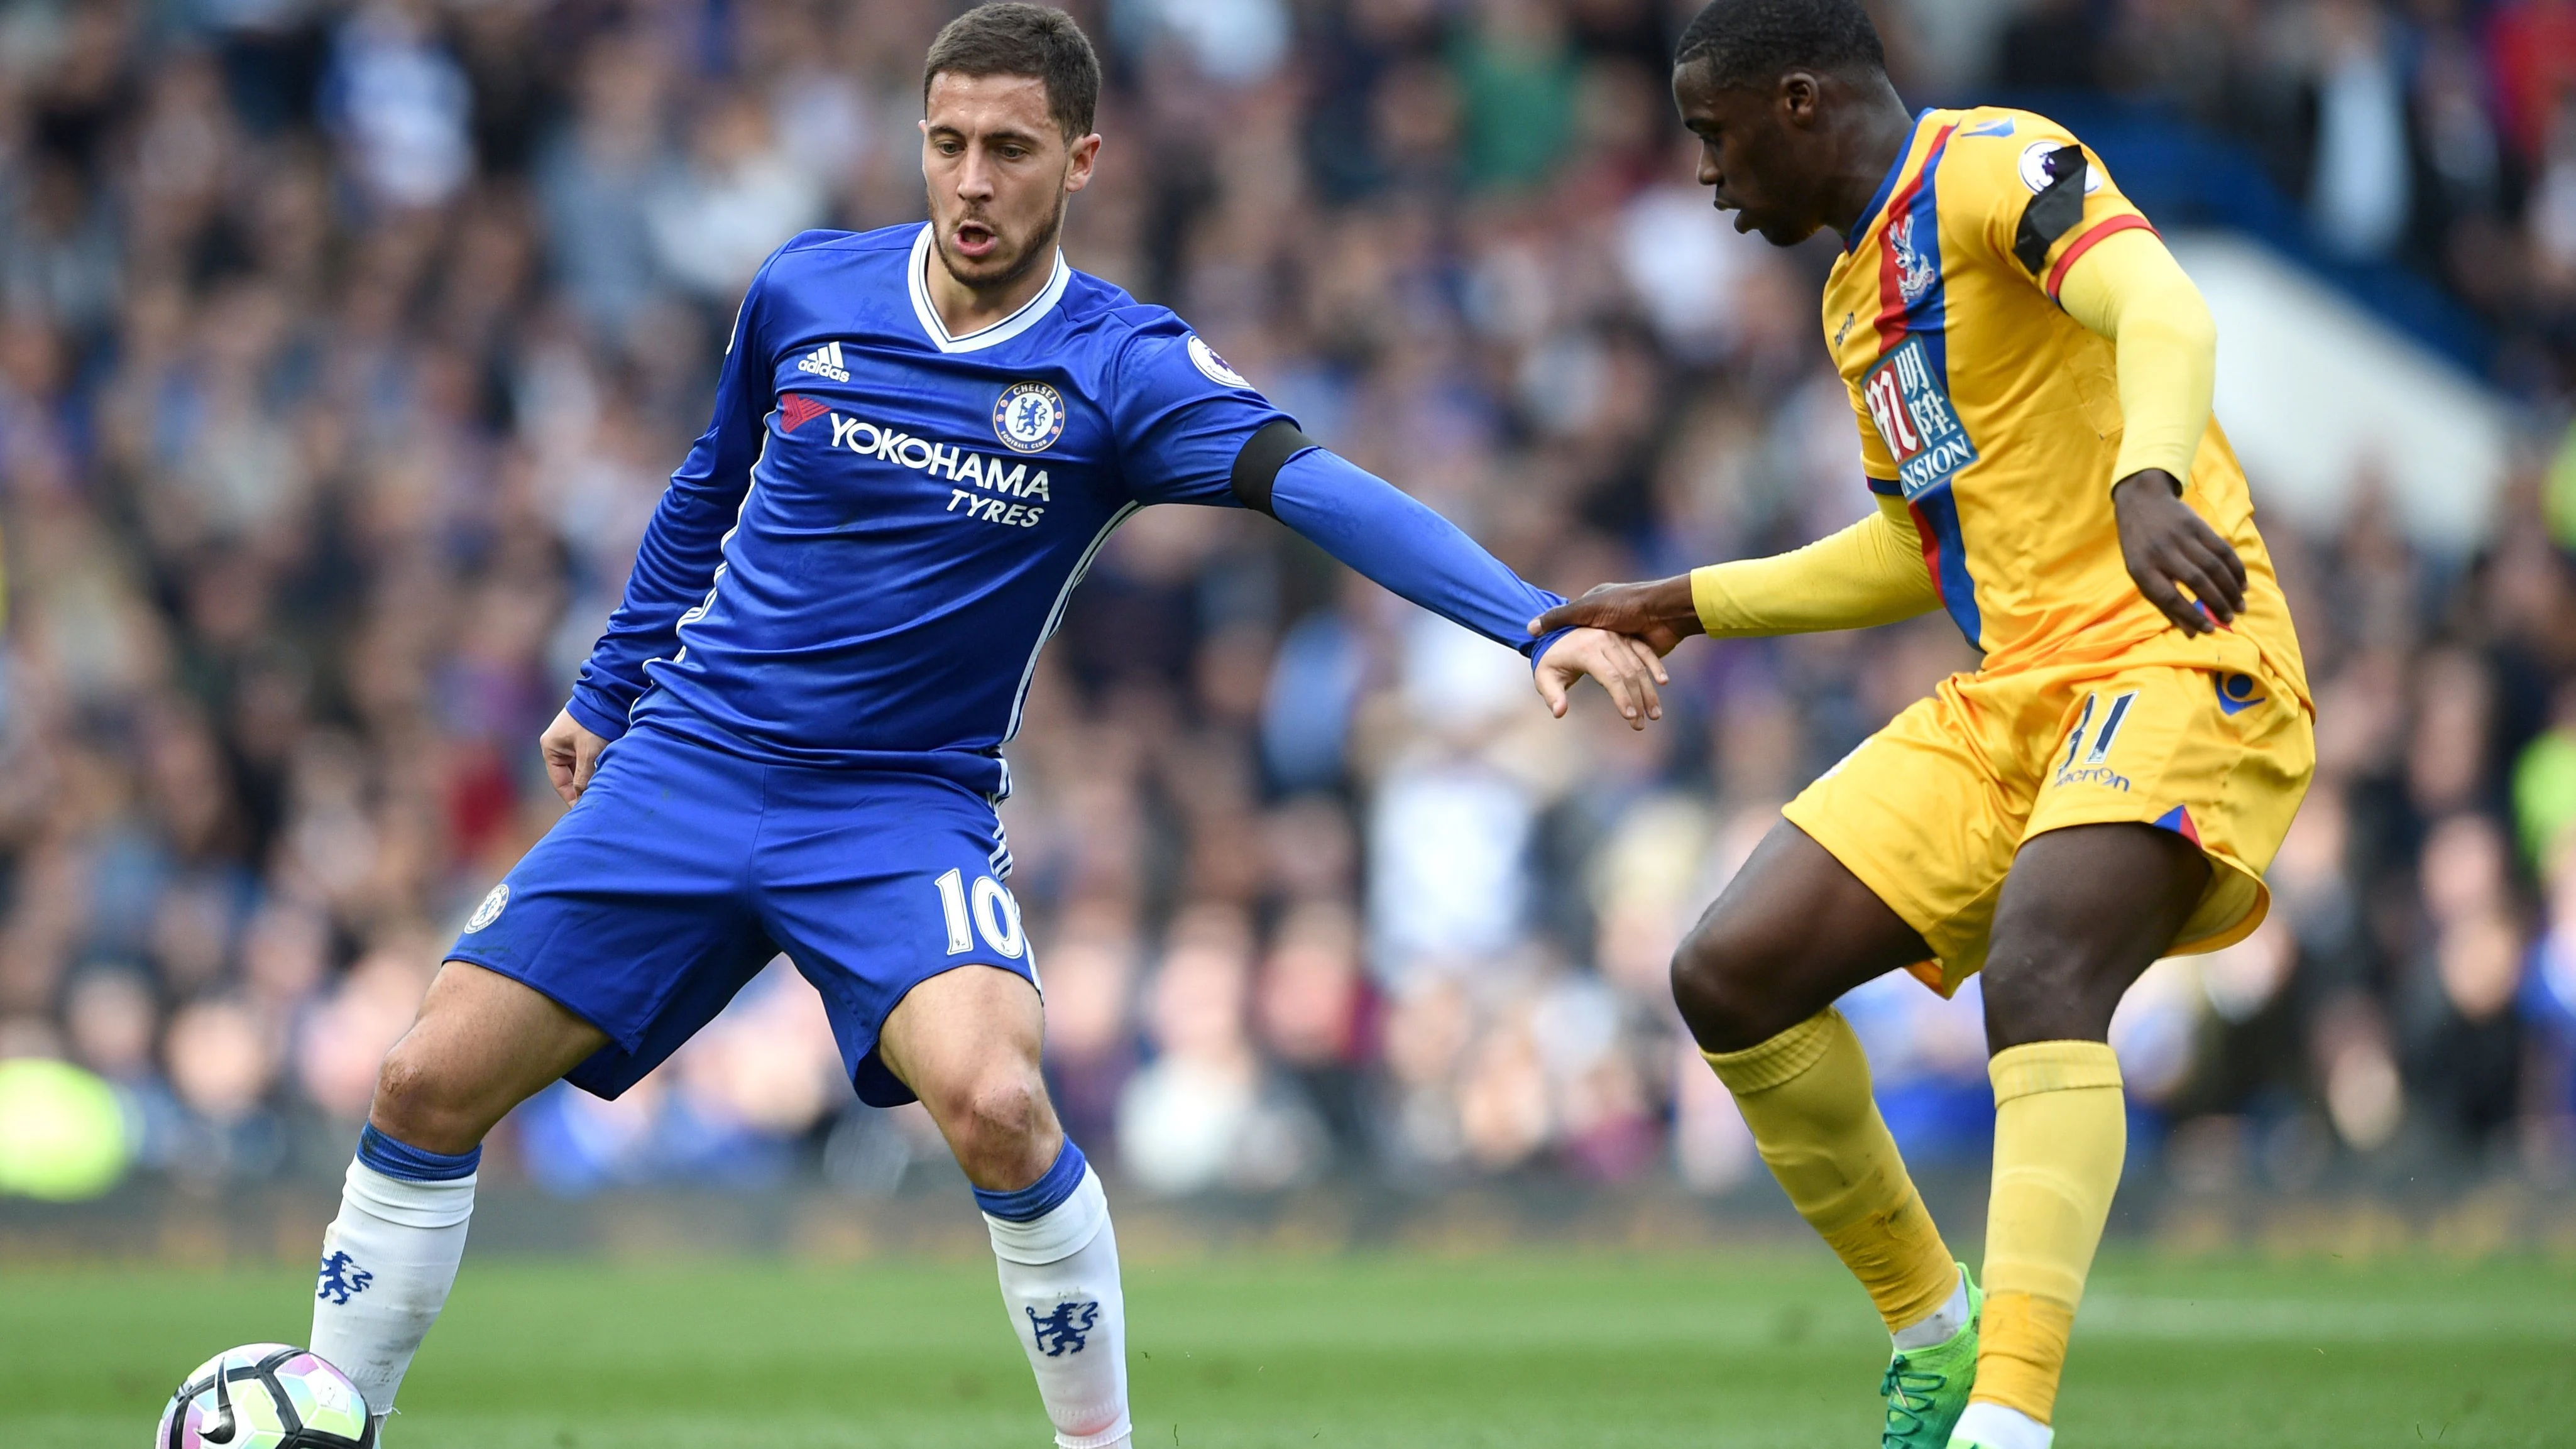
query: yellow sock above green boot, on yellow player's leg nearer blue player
[{"left": 1708, "top": 1009, "right": 1958, "bottom": 1331}]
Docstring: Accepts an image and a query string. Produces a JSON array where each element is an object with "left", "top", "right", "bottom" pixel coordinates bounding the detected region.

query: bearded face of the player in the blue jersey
[{"left": 922, "top": 72, "right": 1100, "bottom": 291}]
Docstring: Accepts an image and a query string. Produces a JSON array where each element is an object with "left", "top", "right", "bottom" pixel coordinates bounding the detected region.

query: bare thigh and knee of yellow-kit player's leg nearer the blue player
[{"left": 1672, "top": 821, "right": 1929, "bottom": 1053}]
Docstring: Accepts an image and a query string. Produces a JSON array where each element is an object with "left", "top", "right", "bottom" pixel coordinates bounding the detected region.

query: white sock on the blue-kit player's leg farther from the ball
[{"left": 977, "top": 1156, "right": 1134, "bottom": 1449}]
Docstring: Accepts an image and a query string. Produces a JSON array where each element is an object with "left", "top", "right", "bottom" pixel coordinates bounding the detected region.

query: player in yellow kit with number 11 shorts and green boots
[{"left": 1535, "top": 0, "right": 2316, "bottom": 1449}]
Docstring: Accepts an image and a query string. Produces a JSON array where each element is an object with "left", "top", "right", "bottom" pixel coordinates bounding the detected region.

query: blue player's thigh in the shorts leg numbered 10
[{"left": 755, "top": 772, "right": 1043, "bottom": 1112}]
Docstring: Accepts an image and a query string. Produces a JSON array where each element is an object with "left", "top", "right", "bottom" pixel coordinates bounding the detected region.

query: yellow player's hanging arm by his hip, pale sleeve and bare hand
[{"left": 2058, "top": 226, "right": 2246, "bottom": 633}]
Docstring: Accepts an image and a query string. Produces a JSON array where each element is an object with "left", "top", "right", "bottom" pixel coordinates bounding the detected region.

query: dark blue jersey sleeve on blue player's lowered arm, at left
[{"left": 567, "top": 258, "right": 778, "bottom": 739}]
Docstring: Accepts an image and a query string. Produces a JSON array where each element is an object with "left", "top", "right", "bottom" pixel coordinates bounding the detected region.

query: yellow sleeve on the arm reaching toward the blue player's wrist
[{"left": 1690, "top": 497, "right": 1940, "bottom": 638}]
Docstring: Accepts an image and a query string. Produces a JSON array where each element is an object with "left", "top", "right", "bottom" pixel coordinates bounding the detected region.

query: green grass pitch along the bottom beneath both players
[{"left": 0, "top": 1249, "right": 2576, "bottom": 1449}]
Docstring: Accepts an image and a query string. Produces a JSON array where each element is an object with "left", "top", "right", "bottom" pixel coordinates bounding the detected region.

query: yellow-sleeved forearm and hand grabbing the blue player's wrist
[{"left": 1528, "top": 500, "right": 1940, "bottom": 653}]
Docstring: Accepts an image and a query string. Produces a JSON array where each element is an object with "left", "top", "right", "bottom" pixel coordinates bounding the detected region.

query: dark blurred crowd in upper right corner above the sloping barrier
[{"left": 1958, "top": 0, "right": 2576, "bottom": 414}]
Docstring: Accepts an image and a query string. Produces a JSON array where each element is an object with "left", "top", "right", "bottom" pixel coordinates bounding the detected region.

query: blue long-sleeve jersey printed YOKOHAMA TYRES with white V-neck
[{"left": 569, "top": 226, "right": 1561, "bottom": 796}]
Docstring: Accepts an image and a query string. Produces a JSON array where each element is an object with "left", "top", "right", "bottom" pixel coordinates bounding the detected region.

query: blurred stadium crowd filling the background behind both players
[{"left": 0, "top": 0, "right": 2576, "bottom": 1210}]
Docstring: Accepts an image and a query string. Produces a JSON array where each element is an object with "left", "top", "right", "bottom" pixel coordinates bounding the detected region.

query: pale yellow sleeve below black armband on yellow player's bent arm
[{"left": 2058, "top": 229, "right": 2218, "bottom": 486}]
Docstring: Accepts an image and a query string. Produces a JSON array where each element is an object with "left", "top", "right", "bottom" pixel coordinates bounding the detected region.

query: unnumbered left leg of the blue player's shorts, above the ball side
[{"left": 448, "top": 731, "right": 778, "bottom": 1096}]
